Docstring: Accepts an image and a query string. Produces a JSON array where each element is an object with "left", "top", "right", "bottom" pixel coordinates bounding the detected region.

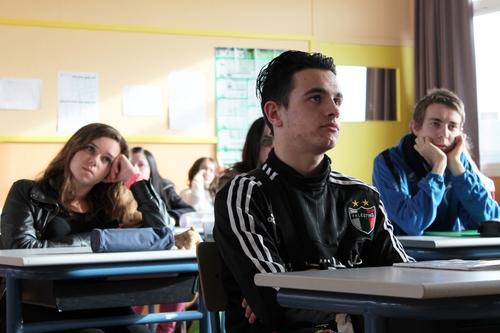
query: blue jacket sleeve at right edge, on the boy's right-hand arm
[{"left": 452, "top": 155, "right": 500, "bottom": 229}]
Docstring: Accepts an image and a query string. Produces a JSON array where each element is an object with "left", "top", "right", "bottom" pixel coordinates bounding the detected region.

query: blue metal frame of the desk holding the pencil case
[{"left": 0, "top": 258, "right": 211, "bottom": 333}]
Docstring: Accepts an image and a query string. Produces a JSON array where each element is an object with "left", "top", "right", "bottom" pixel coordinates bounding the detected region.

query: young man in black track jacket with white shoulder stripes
[{"left": 214, "top": 51, "right": 411, "bottom": 333}]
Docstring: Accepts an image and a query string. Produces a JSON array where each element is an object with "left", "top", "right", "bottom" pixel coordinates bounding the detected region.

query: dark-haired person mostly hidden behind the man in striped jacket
[{"left": 217, "top": 117, "right": 273, "bottom": 190}]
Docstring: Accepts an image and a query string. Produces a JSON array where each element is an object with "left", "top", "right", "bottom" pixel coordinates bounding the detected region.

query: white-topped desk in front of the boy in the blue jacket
[{"left": 398, "top": 236, "right": 500, "bottom": 260}]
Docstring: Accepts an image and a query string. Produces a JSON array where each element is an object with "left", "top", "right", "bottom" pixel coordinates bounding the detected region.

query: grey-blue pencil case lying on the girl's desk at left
[{"left": 90, "top": 227, "right": 175, "bottom": 252}]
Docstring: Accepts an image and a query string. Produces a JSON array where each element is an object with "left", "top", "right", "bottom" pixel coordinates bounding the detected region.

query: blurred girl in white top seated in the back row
[{"left": 180, "top": 157, "right": 217, "bottom": 212}]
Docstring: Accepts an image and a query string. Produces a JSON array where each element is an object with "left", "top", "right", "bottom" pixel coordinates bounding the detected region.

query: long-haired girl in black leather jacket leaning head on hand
[{"left": 0, "top": 123, "right": 168, "bottom": 332}]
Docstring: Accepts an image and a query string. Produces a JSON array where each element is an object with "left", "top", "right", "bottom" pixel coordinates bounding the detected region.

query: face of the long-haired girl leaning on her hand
[{"left": 69, "top": 137, "right": 120, "bottom": 188}]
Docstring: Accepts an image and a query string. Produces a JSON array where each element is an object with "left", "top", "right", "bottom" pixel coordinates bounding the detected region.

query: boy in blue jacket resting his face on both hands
[{"left": 373, "top": 89, "right": 500, "bottom": 235}]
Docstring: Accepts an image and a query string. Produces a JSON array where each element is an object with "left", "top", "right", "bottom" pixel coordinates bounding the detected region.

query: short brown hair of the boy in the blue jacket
[{"left": 413, "top": 88, "right": 465, "bottom": 128}]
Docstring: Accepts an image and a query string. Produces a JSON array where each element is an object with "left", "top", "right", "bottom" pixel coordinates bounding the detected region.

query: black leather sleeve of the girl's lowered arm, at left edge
[{"left": 0, "top": 180, "right": 90, "bottom": 249}]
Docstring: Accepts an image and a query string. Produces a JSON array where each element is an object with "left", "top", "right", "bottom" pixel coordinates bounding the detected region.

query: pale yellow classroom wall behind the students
[{"left": 0, "top": 0, "right": 413, "bottom": 206}]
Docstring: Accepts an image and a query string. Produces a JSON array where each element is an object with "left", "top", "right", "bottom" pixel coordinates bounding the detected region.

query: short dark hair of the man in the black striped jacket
[{"left": 256, "top": 50, "right": 337, "bottom": 132}]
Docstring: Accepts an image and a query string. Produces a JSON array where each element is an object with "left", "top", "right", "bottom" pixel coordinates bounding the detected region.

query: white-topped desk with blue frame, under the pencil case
[{"left": 0, "top": 247, "right": 210, "bottom": 333}]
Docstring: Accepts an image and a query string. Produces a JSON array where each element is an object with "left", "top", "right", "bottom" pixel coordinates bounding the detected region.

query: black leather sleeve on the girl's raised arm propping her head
[{"left": 130, "top": 180, "right": 170, "bottom": 228}]
